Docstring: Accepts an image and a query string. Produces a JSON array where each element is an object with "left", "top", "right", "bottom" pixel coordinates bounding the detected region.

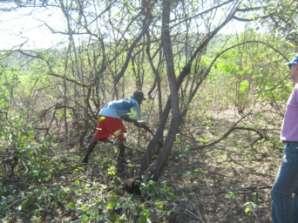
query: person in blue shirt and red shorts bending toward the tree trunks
[{"left": 82, "top": 91, "right": 145, "bottom": 169}]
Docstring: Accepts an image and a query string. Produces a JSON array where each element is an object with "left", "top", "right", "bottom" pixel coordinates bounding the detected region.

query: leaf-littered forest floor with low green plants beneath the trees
[{"left": 0, "top": 109, "right": 282, "bottom": 223}]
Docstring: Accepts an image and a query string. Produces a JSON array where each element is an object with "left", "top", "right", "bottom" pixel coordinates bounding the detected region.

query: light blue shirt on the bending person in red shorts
[{"left": 98, "top": 97, "right": 141, "bottom": 120}]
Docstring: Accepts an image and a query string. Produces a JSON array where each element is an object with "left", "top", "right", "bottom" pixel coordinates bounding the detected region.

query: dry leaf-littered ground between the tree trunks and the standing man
[{"left": 165, "top": 111, "right": 282, "bottom": 223}]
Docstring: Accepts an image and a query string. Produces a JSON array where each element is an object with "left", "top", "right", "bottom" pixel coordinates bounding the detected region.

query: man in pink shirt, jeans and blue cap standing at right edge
[{"left": 271, "top": 55, "right": 298, "bottom": 223}]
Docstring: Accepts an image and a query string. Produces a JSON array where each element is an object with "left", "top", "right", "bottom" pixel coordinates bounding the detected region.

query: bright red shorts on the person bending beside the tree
[{"left": 93, "top": 116, "right": 126, "bottom": 142}]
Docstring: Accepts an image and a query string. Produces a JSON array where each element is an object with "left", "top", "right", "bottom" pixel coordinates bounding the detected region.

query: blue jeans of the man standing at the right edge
[{"left": 271, "top": 144, "right": 298, "bottom": 223}]
